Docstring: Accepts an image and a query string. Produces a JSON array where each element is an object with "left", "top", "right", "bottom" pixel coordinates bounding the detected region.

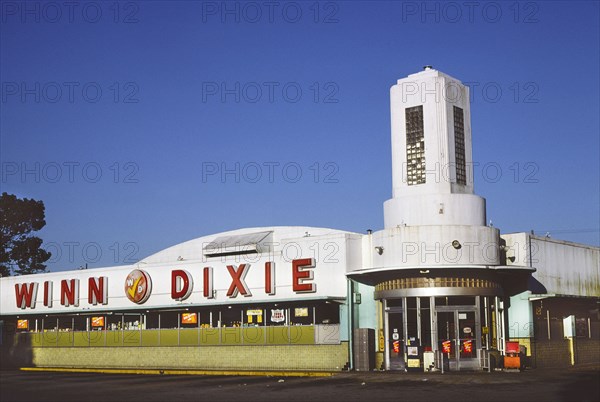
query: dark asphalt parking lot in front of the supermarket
[{"left": 0, "top": 367, "right": 600, "bottom": 402}]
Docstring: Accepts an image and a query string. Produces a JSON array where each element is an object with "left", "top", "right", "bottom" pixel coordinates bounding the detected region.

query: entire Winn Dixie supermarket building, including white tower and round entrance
[{"left": 0, "top": 67, "right": 600, "bottom": 371}]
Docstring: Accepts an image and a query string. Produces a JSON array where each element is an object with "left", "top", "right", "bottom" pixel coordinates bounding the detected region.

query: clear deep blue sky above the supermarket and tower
[{"left": 0, "top": 1, "right": 600, "bottom": 271}]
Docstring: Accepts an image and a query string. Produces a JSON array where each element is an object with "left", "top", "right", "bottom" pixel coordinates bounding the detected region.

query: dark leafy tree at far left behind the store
[{"left": 0, "top": 193, "right": 52, "bottom": 276}]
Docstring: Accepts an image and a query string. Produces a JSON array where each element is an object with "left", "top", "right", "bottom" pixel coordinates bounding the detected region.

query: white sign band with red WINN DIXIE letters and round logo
[{"left": 8, "top": 258, "right": 324, "bottom": 314}]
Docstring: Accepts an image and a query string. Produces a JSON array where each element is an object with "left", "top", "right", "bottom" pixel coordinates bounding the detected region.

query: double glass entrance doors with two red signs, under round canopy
[{"left": 437, "top": 310, "right": 479, "bottom": 370}]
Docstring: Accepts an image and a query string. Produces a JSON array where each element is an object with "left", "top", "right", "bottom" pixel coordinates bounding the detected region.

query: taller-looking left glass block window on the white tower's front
[{"left": 405, "top": 106, "right": 425, "bottom": 186}]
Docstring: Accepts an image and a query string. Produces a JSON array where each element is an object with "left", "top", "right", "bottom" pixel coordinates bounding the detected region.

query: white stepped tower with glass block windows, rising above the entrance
[{"left": 384, "top": 66, "right": 486, "bottom": 228}]
